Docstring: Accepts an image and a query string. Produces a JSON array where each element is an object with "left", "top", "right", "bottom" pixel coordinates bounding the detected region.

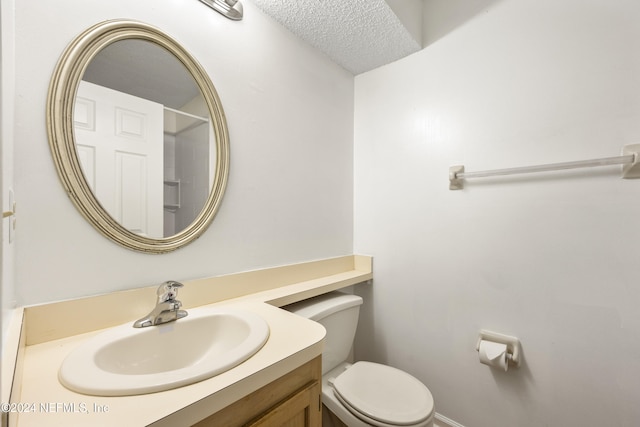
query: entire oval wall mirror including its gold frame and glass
[{"left": 47, "top": 20, "right": 229, "bottom": 253}]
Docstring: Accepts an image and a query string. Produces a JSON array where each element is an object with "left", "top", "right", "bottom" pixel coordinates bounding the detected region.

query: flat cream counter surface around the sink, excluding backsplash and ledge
[{"left": 12, "top": 298, "right": 325, "bottom": 427}]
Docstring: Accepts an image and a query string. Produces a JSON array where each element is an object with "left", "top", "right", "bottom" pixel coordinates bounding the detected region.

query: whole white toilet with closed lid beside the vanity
[{"left": 283, "top": 292, "right": 435, "bottom": 427}]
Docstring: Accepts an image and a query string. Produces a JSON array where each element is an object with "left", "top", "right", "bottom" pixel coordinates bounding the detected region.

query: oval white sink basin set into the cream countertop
[{"left": 58, "top": 307, "right": 269, "bottom": 396}]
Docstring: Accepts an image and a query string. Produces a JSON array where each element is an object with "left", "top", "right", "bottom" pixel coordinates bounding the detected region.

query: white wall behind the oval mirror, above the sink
[{"left": 10, "top": 0, "right": 353, "bottom": 304}]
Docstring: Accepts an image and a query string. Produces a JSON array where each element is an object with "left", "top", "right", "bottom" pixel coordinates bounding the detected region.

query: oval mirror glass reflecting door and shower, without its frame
[{"left": 73, "top": 39, "right": 216, "bottom": 238}]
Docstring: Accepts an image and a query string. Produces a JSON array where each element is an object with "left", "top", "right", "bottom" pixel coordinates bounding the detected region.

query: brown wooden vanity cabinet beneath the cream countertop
[{"left": 190, "top": 357, "right": 322, "bottom": 427}]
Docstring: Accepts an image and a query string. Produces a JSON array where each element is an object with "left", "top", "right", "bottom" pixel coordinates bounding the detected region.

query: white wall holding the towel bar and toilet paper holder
[{"left": 354, "top": 0, "right": 640, "bottom": 427}]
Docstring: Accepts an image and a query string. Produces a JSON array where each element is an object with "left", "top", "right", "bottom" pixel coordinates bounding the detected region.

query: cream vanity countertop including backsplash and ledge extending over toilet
[{"left": 7, "top": 255, "right": 373, "bottom": 427}]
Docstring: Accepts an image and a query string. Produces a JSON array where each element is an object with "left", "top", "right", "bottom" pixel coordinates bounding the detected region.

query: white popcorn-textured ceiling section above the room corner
[{"left": 252, "top": 0, "right": 421, "bottom": 74}]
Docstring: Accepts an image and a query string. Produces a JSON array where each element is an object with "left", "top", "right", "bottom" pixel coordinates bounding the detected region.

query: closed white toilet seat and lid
[{"left": 333, "top": 362, "right": 434, "bottom": 427}]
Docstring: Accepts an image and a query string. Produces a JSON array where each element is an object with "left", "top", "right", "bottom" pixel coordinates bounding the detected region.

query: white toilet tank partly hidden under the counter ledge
[{"left": 282, "top": 292, "right": 362, "bottom": 375}]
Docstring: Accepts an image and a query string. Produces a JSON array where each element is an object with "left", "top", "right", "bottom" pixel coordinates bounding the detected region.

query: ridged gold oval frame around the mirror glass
[{"left": 47, "top": 20, "right": 229, "bottom": 254}]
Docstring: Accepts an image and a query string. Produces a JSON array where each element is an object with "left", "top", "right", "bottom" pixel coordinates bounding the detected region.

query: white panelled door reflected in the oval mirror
[{"left": 74, "top": 81, "right": 163, "bottom": 238}]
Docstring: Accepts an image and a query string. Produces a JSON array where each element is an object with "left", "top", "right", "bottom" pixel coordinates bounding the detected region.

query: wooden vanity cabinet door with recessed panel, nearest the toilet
[{"left": 249, "top": 381, "right": 322, "bottom": 427}]
